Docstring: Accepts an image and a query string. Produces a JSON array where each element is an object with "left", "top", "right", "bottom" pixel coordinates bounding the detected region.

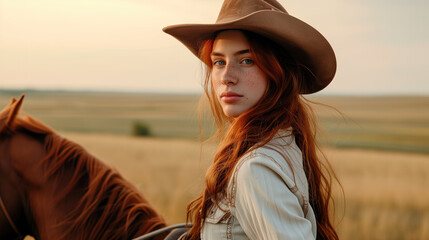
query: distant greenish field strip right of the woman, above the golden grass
[{"left": 315, "top": 96, "right": 429, "bottom": 154}]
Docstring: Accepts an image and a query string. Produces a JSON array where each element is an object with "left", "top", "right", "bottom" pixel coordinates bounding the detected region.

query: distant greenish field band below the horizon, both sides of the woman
[{"left": 0, "top": 91, "right": 429, "bottom": 154}]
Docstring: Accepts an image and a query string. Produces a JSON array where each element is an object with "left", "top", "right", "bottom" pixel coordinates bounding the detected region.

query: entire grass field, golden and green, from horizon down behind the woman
[{"left": 0, "top": 92, "right": 429, "bottom": 240}]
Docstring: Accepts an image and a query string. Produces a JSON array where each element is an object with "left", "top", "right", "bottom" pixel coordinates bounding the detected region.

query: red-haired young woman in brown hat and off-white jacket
[{"left": 164, "top": 0, "right": 338, "bottom": 239}]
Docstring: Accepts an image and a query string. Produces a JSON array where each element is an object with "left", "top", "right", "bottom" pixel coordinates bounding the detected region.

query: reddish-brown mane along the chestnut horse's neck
[{"left": 0, "top": 96, "right": 165, "bottom": 239}]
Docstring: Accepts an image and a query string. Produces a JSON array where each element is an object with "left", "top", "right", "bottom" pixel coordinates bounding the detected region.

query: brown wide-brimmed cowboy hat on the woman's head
[{"left": 163, "top": 0, "right": 337, "bottom": 94}]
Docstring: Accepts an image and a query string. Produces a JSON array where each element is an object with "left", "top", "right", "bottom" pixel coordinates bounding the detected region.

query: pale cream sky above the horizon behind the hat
[{"left": 0, "top": 0, "right": 429, "bottom": 94}]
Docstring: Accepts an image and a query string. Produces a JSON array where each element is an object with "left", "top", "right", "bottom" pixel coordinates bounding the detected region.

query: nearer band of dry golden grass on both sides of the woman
[{"left": 64, "top": 133, "right": 429, "bottom": 240}]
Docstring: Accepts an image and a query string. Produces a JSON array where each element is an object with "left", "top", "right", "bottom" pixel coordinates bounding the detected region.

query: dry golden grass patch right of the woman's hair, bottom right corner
[{"left": 325, "top": 149, "right": 429, "bottom": 239}]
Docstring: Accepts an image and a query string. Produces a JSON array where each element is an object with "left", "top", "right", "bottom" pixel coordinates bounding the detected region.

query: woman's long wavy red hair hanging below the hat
[{"left": 187, "top": 31, "right": 338, "bottom": 239}]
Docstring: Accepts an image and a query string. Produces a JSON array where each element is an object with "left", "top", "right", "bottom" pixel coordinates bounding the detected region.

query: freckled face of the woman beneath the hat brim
[{"left": 210, "top": 30, "right": 267, "bottom": 118}]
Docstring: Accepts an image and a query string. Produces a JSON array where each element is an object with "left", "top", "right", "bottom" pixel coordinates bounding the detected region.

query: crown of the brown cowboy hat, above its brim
[{"left": 216, "top": 0, "right": 288, "bottom": 23}]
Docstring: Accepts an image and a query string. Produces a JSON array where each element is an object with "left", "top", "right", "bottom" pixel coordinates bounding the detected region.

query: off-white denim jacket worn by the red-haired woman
[{"left": 201, "top": 131, "right": 316, "bottom": 240}]
